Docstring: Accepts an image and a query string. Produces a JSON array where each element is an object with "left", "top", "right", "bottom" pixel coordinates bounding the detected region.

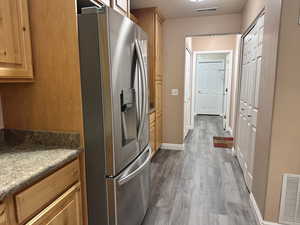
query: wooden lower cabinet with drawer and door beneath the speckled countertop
[{"left": 0, "top": 159, "right": 83, "bottom": 225}]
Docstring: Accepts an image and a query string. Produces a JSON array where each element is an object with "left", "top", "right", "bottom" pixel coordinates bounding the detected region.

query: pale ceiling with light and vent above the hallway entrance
[{"left": 131, "top": 0, "right": 246, "bottom": 18}]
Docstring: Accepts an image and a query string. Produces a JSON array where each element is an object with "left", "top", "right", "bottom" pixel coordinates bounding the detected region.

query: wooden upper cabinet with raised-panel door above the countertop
[{"left": 0, "top": 0, "right": 33, "bottom": 83}]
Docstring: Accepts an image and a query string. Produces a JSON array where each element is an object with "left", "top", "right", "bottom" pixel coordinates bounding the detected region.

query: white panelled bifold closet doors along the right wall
[{"left": 236, "top": 15, "right": 264, "bottom": 190}]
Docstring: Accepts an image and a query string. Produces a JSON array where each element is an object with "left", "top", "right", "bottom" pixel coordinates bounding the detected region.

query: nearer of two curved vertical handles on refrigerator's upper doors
[{"left": 135, "top": 40, "right": 147, "bottom": 138}]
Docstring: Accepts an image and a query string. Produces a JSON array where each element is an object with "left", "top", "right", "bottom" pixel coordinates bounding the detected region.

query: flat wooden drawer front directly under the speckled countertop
[{"left": 15, "top": 159, "right": 80, "bottom": 223}]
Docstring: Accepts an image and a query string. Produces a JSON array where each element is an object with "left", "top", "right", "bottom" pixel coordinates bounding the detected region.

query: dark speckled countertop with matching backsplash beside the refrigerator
[{"left": 0, "top": 130, "right": 80, "bottom": 202}]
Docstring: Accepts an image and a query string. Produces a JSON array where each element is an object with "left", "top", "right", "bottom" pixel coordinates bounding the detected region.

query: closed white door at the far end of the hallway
[{"left": 196, "top": 61, "right": 225, "bottom": 115}]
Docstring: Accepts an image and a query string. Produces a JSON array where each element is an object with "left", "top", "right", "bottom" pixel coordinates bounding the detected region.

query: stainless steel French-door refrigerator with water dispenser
[{"left": 78, "top": 7, "right": 151, "bottom": 225}]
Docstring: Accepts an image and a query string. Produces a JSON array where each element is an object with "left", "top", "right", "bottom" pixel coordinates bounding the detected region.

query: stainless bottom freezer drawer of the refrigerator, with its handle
[{"left": 107, "top": 147, "right": 151, "bottom": 225}]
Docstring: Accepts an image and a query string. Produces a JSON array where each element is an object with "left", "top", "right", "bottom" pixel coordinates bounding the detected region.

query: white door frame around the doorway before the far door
[{"left": 191, "top": 50, "right": 233, "bottom": 131}]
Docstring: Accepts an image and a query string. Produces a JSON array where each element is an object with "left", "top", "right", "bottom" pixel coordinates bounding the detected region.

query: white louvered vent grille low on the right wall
[{"left": 279, "top": 174, "right": 300, "bottom": 225}]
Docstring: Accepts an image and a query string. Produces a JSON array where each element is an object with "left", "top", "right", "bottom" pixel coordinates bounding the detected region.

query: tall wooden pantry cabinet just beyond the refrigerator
[{"left": 132, "top": 8, "right": 163, "bottom": 154}]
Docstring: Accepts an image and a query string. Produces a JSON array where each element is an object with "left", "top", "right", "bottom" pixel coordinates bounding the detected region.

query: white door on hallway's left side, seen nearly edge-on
[{"left": 184, "top": 49, "right": 193, "bottom": 137}]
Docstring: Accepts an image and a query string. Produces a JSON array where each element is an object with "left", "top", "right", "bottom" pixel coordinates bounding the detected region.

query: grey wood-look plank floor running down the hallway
[{"left": 143, "top": 116, "right": 256, "bottom": 225}]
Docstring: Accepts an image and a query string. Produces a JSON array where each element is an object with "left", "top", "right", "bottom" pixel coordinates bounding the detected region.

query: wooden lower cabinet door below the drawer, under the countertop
[{"left": 26, "top": 183, "right": 82, "bottom": 225}]
